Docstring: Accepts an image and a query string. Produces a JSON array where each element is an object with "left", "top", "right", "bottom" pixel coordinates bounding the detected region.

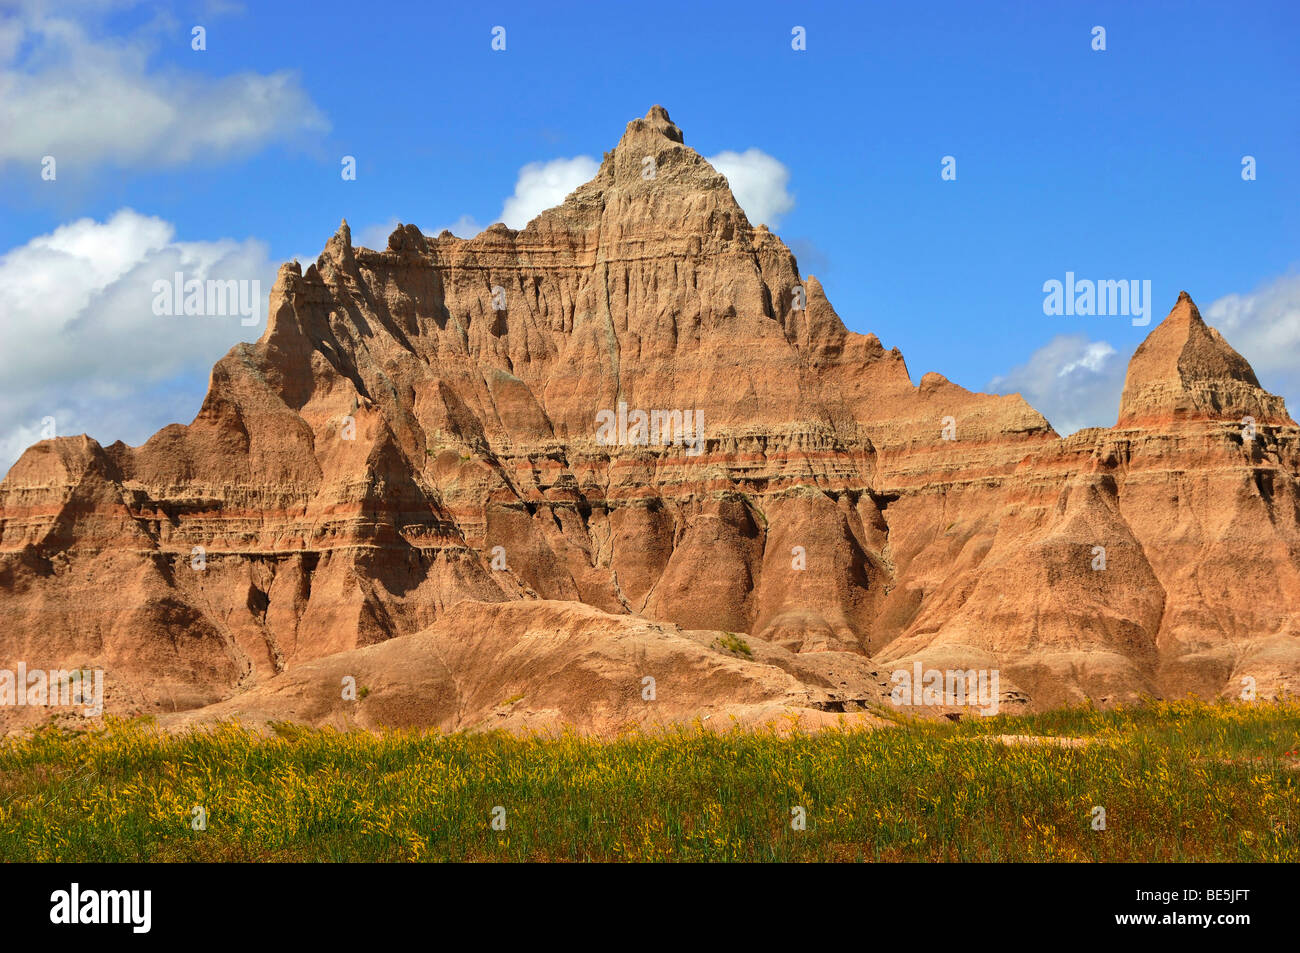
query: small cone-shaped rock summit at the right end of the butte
[{"left": 1119, "top": 291, "right": 1291, "bottom": 426}]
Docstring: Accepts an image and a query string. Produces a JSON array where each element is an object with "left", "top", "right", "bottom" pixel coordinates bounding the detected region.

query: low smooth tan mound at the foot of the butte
[{"left": 161, "top": 599, "right": 888, "bottom": 733}]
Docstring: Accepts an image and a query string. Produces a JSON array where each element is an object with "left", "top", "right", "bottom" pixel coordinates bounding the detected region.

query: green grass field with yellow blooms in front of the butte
[{"left": 0, "top": 702, "right": 1300, "bottom": 862}]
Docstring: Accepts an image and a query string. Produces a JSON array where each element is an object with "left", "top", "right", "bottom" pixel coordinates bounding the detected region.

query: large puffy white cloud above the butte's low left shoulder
[{"left": 0, "top": 209, "right": 276, "bottom": 473}]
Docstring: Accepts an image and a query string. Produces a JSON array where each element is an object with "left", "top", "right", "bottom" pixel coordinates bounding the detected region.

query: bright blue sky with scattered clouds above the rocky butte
[{"left": 0, "top": 0, "right": 1300, "bottom": 467}]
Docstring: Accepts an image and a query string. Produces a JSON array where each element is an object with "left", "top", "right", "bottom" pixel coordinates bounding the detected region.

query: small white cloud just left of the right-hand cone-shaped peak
[{"left": 988, "top": 334, "right": 1128, "bottom": 436}]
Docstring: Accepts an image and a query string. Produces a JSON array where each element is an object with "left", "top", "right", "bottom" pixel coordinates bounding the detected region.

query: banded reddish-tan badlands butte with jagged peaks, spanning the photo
[{"left": 0, "top": 107, "right": 1300, "bottom": 732}]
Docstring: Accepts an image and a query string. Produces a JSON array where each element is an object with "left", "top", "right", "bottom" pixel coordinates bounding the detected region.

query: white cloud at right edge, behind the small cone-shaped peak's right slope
[{"left": 1201, "top": 274, "right": 1300, "bottom": 400}]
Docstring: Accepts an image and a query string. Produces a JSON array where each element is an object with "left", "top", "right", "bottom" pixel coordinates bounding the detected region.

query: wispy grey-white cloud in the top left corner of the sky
[{"left": 0, "top": 4, "right": 329, "bottom": 169}]
